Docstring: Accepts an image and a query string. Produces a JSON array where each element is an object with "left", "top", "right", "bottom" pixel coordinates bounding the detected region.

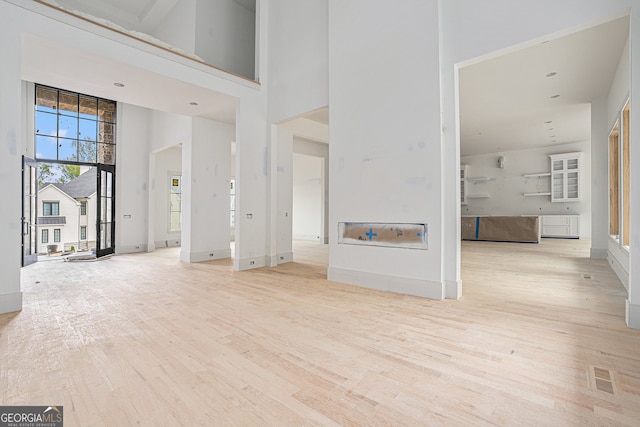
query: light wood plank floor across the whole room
[{"left": 0, "top": 240, "right": 640, "bottom": 427}]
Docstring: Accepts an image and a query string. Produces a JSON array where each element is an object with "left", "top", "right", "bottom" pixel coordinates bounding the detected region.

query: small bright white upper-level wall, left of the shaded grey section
[{"left": 151, "top": 0, "right": 196, "bottom": 53}]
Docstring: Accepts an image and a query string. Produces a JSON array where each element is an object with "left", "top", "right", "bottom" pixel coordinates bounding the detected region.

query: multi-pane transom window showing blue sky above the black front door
[{"left": 35, "top": 85, "right": 116, "bottom": 165}]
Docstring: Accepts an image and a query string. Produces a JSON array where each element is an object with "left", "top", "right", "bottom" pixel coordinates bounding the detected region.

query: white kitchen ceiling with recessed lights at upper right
[{"left": 459, "top": 18, "right": 629, "bottom": 155}]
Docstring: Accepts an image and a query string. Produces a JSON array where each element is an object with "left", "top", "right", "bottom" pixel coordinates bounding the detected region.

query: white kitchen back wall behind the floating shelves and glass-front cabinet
[{"left": 460, "top": 141, "right": 591, "bottom": 238}]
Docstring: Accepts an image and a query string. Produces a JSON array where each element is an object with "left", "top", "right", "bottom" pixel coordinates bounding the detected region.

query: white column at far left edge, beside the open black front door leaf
[{"left": 0, "top": 28, "right": 26, "bottom": 313}]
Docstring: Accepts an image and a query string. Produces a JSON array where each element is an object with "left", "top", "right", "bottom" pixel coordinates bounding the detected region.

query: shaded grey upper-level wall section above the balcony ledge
[{"left": 195, "top": 0, "right": 256, "bottom": 79}]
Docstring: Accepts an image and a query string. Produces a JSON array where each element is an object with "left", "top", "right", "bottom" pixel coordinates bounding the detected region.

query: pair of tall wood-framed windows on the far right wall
[{"left": 609, "top": 102, "right": 631, "bottom": 249}]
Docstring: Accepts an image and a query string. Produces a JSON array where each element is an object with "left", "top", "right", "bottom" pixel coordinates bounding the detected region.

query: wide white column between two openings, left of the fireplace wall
[{"left": 180, "top": 117, "right": 234, "bottom": 262}]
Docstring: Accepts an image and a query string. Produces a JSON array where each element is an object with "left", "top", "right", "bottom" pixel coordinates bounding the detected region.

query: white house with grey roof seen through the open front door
[{"left": 37, "top": 168, "right": 96, "bottom": 254}]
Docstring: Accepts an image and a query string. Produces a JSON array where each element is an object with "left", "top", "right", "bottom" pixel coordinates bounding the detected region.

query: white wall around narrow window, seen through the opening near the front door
[{"left": 152, "top": 145, "right": 182, "bottom": 248}]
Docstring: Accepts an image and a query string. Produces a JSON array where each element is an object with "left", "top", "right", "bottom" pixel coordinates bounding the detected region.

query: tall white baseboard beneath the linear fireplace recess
[{"left": 327, "top": 267, "right": 444, "bottom": 300}]
